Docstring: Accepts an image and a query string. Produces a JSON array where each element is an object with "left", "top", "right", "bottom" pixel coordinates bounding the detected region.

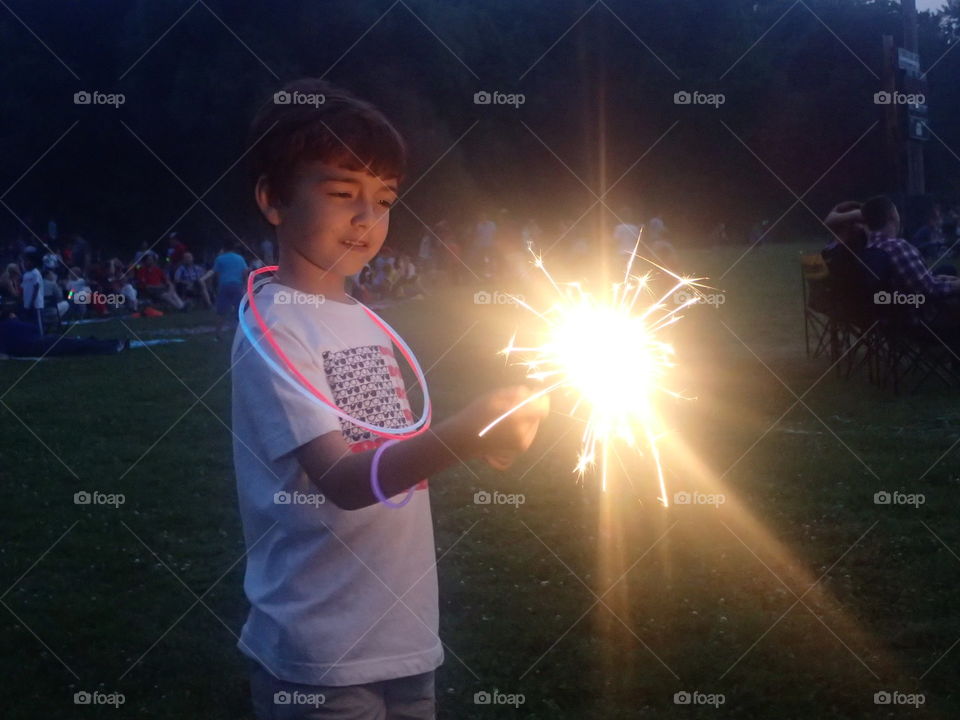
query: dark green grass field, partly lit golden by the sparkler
[{"left": 0, "top": 245, "right": 960, "bottom": 720}]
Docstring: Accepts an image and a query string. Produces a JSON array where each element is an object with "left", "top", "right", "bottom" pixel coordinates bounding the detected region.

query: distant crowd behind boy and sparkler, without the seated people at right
[{"left": 0, "top": 207, "right": 674, "bottom": 354}]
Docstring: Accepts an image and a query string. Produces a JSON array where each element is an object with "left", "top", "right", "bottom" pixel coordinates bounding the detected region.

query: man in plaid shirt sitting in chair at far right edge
[{"left": 861, "top": 195, "right": 960, "bottom": 300}]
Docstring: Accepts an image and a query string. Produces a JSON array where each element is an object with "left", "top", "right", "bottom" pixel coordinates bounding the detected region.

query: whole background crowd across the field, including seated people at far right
[{"left": 9, "top": 197, "right": 960, "bottom": 354}]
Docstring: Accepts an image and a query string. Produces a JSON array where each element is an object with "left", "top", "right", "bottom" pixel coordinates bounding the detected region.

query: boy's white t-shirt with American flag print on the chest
[{"left": 233, "top": 283, "right": 443, "bottom": 686}]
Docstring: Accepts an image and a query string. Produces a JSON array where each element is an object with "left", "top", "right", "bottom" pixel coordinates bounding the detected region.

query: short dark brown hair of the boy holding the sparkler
[{"left": 247, "top": 78, "right": 407, "bottom": 205}]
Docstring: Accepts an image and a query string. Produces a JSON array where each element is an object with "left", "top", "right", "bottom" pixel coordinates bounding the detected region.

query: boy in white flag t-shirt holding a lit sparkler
[{"left": 232, "top": 79, "right": 548, "bottom": 720}]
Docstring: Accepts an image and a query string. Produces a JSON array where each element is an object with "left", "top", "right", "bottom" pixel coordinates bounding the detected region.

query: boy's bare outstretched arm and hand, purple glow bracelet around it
[{"left": 295, "top": 387, "right": 549, "bottom": 510}]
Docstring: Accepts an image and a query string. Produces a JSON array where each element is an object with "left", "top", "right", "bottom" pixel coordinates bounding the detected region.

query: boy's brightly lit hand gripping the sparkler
[{"left": 454, "top": 385, "right": 550, "bottom": 470}]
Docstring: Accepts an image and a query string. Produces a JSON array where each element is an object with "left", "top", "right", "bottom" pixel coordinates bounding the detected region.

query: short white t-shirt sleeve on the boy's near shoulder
[{"left": 234, "top": 319, "right": 341, "bottom": 462}]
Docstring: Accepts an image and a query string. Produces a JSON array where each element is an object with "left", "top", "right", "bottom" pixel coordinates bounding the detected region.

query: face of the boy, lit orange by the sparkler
[{"left": 277, "top": 162, "right": 397, "bottom": 277}]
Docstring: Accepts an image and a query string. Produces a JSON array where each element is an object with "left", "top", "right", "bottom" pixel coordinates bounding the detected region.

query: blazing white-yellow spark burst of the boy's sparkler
[{"left": 480, "top": 237, "right": 704, "bottom": 506}]
